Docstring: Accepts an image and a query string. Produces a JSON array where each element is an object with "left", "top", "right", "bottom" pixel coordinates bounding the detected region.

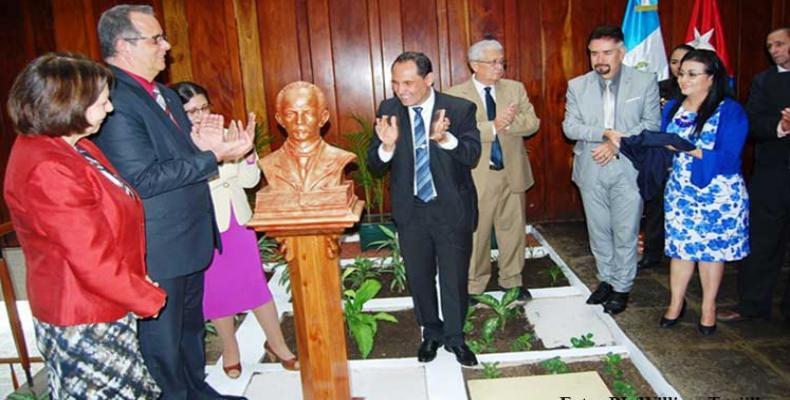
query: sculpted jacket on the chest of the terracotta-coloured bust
[{"left": 260, "top": 141, "right": 355, "bottom": 192}]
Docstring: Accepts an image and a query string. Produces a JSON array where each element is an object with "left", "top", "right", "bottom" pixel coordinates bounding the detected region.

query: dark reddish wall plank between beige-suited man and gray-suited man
[{"left": 507, "top": 1, "right": 556, "bottom": 221}]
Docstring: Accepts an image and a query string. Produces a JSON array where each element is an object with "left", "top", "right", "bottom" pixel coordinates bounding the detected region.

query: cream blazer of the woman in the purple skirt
[{"left": 208, "top": 157, "right": 261, "bottom": 232}]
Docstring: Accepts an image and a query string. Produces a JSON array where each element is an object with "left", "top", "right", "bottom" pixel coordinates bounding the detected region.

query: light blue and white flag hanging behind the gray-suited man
[{"left": 623, "top": 0, "right": 669, "bottom": 81}]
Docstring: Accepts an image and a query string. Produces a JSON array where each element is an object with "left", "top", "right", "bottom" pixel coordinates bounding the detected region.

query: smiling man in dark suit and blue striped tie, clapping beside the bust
[{"left": 368, "top": 52, "right": 480, "bottom": 366}]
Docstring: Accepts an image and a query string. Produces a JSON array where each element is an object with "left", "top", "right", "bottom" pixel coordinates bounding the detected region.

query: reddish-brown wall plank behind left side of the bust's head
[{"left": 256, "top": 0, "right": 304, "bottom": 147}]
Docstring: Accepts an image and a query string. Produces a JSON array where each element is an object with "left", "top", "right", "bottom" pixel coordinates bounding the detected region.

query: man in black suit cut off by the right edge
[{"left": 717, "top": 27, "right": 790, "bottom": 322}]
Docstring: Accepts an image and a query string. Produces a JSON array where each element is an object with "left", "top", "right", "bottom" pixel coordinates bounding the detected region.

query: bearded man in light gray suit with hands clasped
[{"left": 562, "top": 26, "right": 661, "bottom": 314}]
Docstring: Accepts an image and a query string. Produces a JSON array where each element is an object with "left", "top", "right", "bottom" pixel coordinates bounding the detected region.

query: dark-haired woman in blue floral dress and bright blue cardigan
[{"left": 660, "top": 50, "right": 749, "bottom": 335}]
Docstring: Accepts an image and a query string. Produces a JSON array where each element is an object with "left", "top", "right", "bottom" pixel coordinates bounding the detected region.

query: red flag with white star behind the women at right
[{"left": 686, "top": 0, "right": 735, "bottom": 80}]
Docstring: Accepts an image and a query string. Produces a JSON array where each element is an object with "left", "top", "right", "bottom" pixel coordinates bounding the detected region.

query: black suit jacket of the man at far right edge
[{"left": 746, "top": 67, "right": 790, "bottom": 173}]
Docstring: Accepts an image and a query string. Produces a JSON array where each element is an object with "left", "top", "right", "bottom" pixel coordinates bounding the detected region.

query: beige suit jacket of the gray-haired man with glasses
[{"left": 445, "top": 78, "right": 540, "bottom": 193}]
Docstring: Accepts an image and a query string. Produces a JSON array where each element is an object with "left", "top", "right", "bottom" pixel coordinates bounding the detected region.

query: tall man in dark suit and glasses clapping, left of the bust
[{"left": 95, "top": 5, "right": 254, "bottom": 400}]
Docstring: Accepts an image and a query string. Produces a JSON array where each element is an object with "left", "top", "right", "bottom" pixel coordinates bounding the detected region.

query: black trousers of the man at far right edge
[{"left": 738, "top": 168, "right": 790, "bottom": 318}]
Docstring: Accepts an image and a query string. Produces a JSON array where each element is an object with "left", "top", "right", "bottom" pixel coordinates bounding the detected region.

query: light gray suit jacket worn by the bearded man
[{"left": 562, "top": 65, "right": 661, "bottom": 188}]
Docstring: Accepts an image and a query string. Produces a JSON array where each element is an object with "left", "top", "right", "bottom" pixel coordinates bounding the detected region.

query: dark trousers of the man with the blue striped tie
[{"left": 397, "top": 200, "right": 472, "bottom": 346}]
